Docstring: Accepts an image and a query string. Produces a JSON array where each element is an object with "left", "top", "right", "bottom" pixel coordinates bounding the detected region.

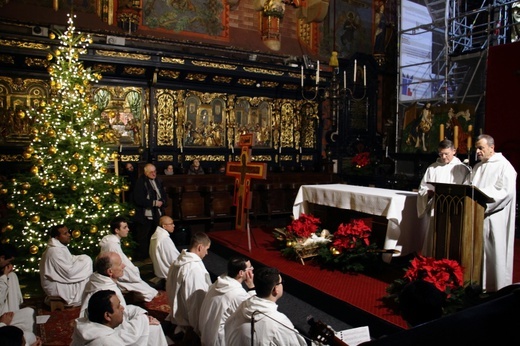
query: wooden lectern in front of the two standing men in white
[{"left": 429, "top": 183, "right": 493, "bottom": 284}]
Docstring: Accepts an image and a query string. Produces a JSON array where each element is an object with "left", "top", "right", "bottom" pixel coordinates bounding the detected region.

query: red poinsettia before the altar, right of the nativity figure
[{"left": 332, "top": 219, "right": 372, "bottom": 252}]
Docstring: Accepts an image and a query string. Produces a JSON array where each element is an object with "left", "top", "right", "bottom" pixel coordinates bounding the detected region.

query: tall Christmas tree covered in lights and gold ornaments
[{"left": 0, "top": 12, "right": 129, "bottom": 273}]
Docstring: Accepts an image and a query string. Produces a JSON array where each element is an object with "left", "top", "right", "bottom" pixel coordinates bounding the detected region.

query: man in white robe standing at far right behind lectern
[{"left": 473, "top": 135, "right": 517, "bottom": 292}]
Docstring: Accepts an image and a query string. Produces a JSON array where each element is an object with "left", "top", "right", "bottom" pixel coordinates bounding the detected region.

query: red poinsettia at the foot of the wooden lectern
[{"left": 404, "top": 256, "right": 464, "bottom": 298}]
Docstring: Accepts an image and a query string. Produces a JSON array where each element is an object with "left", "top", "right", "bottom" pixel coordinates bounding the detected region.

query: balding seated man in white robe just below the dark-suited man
[{"left": 150, "top": 216, "right": 180, "bottom": 279}]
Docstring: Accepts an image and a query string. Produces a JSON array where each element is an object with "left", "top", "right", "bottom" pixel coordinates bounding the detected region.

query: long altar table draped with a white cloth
[{"left": 293, "top": 184, "right": 428, "bottom": 262}]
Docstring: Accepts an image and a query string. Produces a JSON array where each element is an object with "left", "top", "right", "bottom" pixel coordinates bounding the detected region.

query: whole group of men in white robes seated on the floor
[{"left": 0, "top": 216, "right": 307, "bottom": 346}]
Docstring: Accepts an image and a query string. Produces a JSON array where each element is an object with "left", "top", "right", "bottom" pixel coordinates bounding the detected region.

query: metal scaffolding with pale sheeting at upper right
[{"left": 396, "top": 0, "right": 520, "bottom": 141}]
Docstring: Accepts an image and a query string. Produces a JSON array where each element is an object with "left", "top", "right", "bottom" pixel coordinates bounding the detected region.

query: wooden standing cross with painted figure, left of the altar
[{"left": 226, "top": 134, "right": 267, "bottom": 231}]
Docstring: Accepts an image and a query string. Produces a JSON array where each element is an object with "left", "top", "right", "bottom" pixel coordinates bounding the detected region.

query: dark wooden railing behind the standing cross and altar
[{"left": 159, "top": 172, "right": 340, "bottom": 229}]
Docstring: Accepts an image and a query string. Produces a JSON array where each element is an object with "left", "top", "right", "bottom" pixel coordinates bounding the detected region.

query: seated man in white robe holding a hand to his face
[{"left": 199, "top": 256, "right": 256, "bottom": 346}]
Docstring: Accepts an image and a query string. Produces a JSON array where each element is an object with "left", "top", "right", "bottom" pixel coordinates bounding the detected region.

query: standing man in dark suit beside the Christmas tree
[{"left": 134, "top": 163, "right": 167, "bottom": 259}]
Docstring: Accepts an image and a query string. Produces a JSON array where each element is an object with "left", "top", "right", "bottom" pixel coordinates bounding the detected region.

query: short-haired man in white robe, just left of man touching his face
[{"left": 166, "top": 232, "right": 211, "bottom": 337}]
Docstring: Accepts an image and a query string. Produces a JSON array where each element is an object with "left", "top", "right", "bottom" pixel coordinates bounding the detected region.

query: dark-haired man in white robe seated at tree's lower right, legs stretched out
[{"left": 99, "top": 217, "right": 158, "bottom": 302}]
